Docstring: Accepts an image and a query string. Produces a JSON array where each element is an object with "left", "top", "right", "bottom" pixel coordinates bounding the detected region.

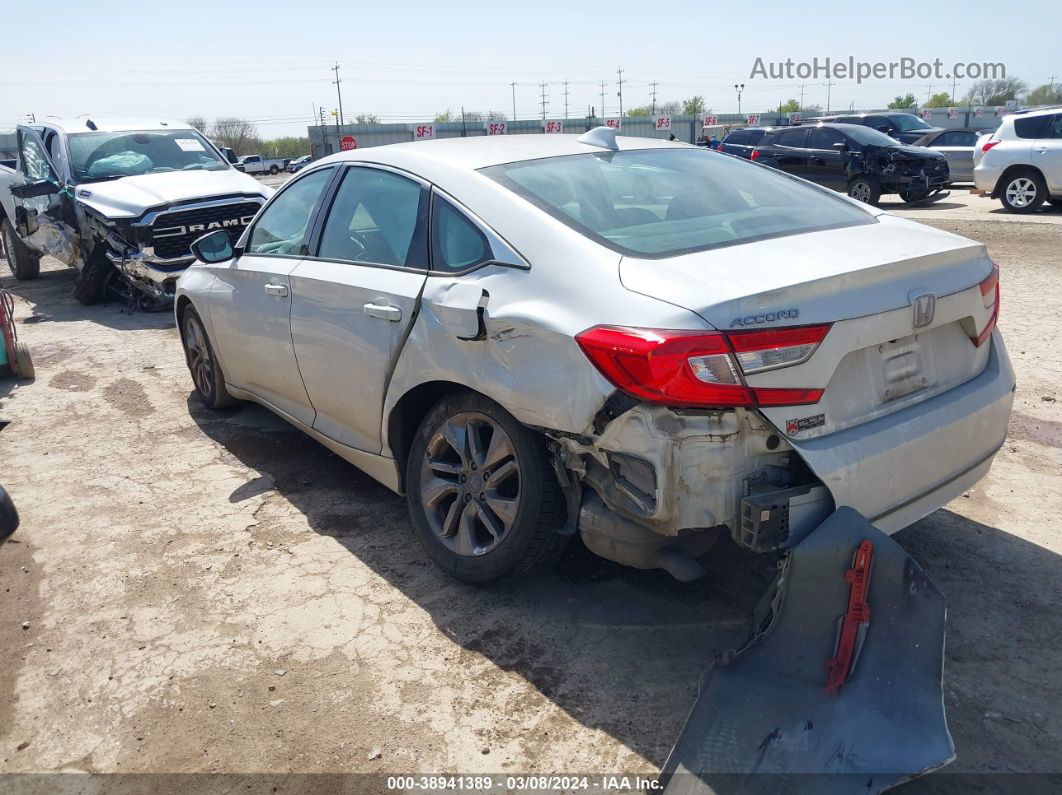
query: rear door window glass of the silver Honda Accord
[{"left": 318, "top": 167, "right": 428, "bottom": 267}]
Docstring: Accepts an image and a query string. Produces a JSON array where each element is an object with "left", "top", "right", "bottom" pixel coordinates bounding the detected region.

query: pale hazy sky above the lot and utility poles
[{"left": 0, "top": 0, "right": 1062, "bottom": 137}]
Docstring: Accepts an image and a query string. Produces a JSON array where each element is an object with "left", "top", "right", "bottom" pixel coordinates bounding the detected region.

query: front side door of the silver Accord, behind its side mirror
[{"left": 208, "top": 168, "right": 336, "bottom": 426}]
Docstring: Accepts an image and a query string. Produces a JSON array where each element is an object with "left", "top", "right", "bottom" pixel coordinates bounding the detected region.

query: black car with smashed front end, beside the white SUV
[{"left": 751, "top": 124, "right": 949, "bottom": 204}]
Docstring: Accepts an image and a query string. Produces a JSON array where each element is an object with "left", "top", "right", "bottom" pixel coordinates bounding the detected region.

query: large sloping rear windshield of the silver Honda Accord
[{"left": 481, "top": 149, "right": 874, "bottom": 257}]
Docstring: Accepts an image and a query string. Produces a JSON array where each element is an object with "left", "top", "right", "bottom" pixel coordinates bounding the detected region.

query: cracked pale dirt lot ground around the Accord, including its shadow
[{"left": 0, "top": 197, "right": 1062, "bottom": 792}]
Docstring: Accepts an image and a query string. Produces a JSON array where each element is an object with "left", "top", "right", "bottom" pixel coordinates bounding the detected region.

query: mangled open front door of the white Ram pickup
[{"left": 11, "top": 127, "right": 81, "bottom": 265}]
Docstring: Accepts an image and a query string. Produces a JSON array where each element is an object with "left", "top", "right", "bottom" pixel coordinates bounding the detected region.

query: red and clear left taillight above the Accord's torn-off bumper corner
[{"left": 576, "top": 325, "right": 829, "bottom": 407}]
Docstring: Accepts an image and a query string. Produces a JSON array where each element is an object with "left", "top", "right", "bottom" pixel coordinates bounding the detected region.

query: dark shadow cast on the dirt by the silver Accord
[{"left": 188, "top": 396, "right": 1062, "bottom": 776}]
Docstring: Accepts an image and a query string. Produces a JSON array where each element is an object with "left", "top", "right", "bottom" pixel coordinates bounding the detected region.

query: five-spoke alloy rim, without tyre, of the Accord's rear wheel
[{"left": 419, "top": 412, "right": 521, "bottom": 557}]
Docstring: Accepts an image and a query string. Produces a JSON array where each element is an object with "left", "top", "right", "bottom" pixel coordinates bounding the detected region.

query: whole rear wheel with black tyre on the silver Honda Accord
[{"left": 406, "top": 391, "right": 568, "bottom": 583}]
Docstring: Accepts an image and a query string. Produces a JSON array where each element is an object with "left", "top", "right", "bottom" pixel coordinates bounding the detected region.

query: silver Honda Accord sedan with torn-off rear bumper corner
[{"left": 175, "top": 128, "right": 1014, "bottom": 582}]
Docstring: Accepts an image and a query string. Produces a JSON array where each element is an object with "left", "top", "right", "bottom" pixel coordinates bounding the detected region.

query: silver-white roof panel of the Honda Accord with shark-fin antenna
[{"left": 318, "top": 133, "right": 683, "bottom": 172}]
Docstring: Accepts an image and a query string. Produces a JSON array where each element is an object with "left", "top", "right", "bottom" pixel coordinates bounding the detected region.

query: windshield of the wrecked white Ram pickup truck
[{"left": 68, "top": 129, "right": 228, "bottom": 182}]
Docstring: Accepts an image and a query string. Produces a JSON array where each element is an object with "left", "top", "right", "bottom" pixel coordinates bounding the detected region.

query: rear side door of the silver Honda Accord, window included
[{"left": 291, "top": 163, "right": 430, "bottom": 453}]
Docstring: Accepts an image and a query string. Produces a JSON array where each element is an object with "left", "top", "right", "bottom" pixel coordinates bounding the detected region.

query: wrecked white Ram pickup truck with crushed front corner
[{"left": 0, "top": 119, "right": 273, "bottom": 309}]
